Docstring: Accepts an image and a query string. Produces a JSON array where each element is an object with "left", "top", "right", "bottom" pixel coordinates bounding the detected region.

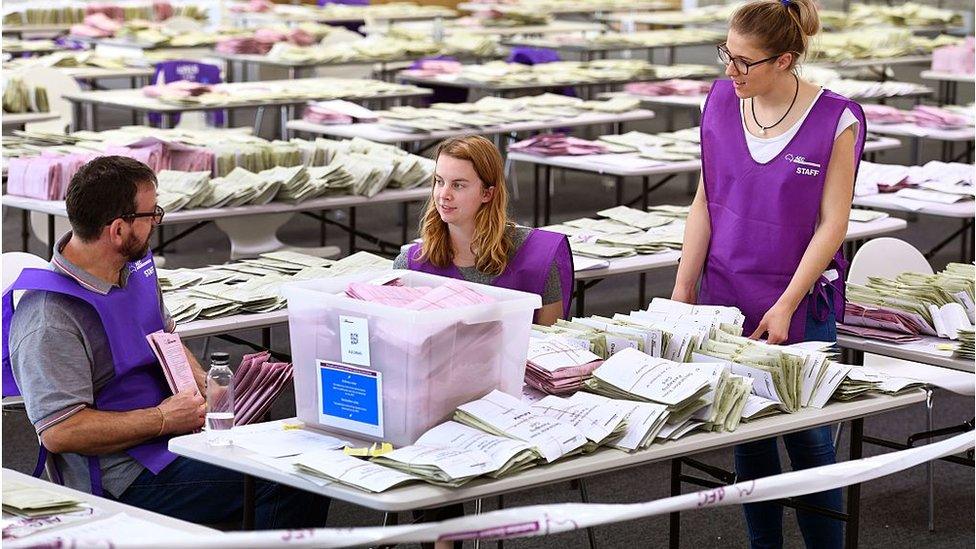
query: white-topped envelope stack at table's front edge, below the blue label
[{"left": 295, "top": 450, "right": 423, "bottom": 493}]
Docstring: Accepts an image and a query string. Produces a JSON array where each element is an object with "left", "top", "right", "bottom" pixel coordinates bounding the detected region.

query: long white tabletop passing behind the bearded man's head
[{"left": 0, "top": 186, "right": 430, "bottom": 225}]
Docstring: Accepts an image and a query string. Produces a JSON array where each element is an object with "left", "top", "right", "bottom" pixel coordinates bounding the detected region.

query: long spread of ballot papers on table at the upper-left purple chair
[{"left": 142, "top": 78, "right": 425, "bottom": 107}]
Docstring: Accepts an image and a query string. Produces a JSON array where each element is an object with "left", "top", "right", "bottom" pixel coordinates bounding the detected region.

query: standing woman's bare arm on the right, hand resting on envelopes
[{"left": 750, "top": 126, "right": 857, "bottom": 344}]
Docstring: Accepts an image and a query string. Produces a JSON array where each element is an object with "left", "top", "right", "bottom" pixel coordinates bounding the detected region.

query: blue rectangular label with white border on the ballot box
[{"left": 316, "top": 360, "right": 383, "bottom": 437}]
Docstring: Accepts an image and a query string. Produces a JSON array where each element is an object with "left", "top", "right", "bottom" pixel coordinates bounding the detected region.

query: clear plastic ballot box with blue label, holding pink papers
[{"left": 282, "top": 271, "right": 542, "bottom": 446}]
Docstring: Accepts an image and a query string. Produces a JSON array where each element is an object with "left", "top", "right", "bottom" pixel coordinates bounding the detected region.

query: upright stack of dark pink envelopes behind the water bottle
[{"left": 234, "top": 351, "right": 292, "bottom": 425}]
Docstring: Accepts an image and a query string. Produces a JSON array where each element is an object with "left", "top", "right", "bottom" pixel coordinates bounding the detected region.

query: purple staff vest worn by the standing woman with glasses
[{"left": 698, "top": 80, "right": 865, "bottom": 343}]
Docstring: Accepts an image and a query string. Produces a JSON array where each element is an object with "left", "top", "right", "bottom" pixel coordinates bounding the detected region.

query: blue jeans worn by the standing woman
[{"left": 735, "top": 298, "right": 844, "bottom": 549}]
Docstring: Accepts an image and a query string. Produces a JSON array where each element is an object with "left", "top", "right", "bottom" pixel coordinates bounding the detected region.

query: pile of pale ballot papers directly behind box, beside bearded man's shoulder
[{"left": 157, "top": 251, "right": 393, "bottom": 324}]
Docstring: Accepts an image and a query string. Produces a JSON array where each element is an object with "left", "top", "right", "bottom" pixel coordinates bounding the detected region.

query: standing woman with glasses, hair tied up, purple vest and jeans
[{"left": 672, "top": 0, "right": 865, "bottom": 549}]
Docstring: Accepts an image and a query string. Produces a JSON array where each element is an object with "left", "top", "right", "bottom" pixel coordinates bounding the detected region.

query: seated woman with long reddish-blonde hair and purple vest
[{"left": 394, "top": 136, "right": 573, "bottom": 325}]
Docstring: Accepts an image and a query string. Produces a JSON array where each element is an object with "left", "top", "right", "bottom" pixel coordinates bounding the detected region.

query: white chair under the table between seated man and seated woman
[{"left": 215, "top": 213, "right": 339, "bottom": 259}]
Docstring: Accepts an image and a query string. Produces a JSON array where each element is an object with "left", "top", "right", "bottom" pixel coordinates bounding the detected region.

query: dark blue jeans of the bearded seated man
[{"left": 118, "top": 457, "right": 332, "bottom": 530}]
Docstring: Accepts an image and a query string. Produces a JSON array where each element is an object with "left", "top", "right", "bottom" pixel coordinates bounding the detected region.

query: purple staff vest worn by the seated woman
[{"left": 407, "top": 229, "right": 573, "bottom": 318}]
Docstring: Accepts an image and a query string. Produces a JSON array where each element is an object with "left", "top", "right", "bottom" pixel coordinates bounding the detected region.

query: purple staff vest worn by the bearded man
[{"left": 2, "top": 252, "right": 176, "bottom": 495}]
